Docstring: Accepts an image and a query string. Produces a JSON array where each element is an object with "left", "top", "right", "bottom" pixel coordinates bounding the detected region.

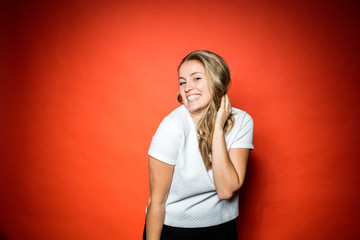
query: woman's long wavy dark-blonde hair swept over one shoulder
[{"left": 177, "top": 50, "right": 235, "bottom": 170}]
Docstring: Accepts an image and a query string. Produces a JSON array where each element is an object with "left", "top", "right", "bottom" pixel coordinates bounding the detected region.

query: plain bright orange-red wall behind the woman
[{"left": 0, "top": 0, "right": 360, "bottom": 240}]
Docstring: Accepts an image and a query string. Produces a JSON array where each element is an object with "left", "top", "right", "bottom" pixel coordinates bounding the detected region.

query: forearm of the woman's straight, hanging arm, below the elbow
[{"left": 146, "top": 202, "right": 165, "bottom": 240}]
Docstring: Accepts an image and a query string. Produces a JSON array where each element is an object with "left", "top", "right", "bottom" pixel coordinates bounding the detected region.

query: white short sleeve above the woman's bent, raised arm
[{"left": 231, "top": 112, "right": 254, "bottom": 149}]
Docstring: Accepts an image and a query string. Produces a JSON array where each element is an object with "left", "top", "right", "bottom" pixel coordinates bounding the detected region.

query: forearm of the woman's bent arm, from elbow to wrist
[{"left": 212, "top": 127, "right": 241, "bottom": 199}]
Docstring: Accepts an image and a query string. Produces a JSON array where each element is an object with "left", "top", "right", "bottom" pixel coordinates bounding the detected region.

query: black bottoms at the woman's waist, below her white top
[{"left": 143, "top": 220, "right": 238, "bottom": 240}]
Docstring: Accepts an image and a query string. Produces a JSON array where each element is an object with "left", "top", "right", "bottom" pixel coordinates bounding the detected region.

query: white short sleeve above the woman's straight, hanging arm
[{"left": 148, "top": 117, "right": 182, "bottom": 165}]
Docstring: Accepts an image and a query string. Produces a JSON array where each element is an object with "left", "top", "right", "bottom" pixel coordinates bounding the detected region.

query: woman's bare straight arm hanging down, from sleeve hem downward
[{"left": 146, "top": 156, "right": 174, "bottom": 240}]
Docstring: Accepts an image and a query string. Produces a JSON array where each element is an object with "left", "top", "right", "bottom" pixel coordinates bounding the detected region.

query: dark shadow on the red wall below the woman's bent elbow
[{"left": 236, "top": 154, "right": 266, "bottom": 239}]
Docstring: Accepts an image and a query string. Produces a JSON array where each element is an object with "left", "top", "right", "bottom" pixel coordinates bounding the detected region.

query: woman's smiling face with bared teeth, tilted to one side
[{"left": 179, "top": 60, "right": 212, "bottom": 120}]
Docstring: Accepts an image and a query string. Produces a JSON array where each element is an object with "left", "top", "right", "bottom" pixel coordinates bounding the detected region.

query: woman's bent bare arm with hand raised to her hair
[{"left": 211, "top": 94, "right": 250, "bottom": 199}]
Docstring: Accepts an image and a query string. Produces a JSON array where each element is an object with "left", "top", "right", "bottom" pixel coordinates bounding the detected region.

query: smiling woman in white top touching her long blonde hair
[{"left": 144, "top": 51, "right": 253, "bottom": 240}]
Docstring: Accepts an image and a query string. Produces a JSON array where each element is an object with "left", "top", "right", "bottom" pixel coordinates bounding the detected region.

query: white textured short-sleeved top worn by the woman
[{"left": 149, "top": 105, "right": 254, "bottom": 228}]
